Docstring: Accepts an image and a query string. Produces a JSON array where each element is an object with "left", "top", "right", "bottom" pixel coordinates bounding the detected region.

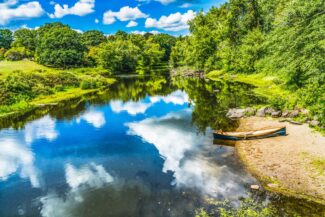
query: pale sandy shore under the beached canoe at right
[{"left": 236, "top": 117, "right": 325, "bottom": 205}]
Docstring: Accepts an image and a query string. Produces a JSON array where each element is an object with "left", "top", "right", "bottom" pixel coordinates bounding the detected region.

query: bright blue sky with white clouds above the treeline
[{"left": 0, "top": 0, "right": 226, "bottom": 35}]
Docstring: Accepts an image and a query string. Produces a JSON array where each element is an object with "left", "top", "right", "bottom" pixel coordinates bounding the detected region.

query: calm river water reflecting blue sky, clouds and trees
[{"left": 0, "top": 77, "right": 322, "bottom": 217}]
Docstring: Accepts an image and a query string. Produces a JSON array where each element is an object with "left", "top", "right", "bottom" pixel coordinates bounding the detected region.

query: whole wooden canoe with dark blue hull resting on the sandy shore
[{"left": 213, "top": 127, "right": 286, "bottom": 141}]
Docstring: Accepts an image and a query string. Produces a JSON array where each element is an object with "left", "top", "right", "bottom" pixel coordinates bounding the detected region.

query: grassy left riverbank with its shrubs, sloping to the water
[{"left": 0, "top": 60, "right": 115, "bottom": 117}]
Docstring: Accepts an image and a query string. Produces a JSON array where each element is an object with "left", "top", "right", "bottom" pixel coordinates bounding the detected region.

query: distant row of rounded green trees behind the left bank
[{"left": 0, "top": 23, "right": 176, "bottom": 73}]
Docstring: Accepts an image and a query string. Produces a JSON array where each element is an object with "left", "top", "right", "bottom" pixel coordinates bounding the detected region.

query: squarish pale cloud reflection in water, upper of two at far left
[{"left": 25, "top": 115, "right": 58, "bottom": 144}]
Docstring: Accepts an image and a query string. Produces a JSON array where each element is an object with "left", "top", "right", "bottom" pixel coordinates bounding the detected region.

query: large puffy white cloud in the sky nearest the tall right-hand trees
[{"left": 145, "top": 10, "right": 196, "bottom": 32}]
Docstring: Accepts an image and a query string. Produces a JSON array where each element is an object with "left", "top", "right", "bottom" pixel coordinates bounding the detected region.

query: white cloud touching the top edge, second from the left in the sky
[{"left": 49, "top": 0, "right": 95, "bottom": 18}]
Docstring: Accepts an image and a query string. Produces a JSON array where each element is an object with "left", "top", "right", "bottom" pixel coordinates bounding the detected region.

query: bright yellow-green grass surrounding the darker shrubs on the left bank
[{"left": 0, "top": 60, "right": 115, "bottom": 117}]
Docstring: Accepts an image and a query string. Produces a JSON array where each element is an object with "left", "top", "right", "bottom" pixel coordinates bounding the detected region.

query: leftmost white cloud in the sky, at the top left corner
[{"left": 0, "top": 0, "right": 44, "bottom": 25}]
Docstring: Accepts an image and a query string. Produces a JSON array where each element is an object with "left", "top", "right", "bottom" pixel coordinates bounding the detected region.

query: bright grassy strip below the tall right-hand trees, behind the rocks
[{"left": 206, "top": 71, "right": 325, "bottom": 132}]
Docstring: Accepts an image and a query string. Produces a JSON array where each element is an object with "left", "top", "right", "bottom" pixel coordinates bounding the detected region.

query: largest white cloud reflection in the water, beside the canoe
[{"left": 127, "top": 109, "right": 252, "bottom": 199}]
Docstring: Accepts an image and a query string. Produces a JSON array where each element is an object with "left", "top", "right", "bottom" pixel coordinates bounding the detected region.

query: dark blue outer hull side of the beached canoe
[{"left": 213, "top": 127, "right": 287, "bottom": 141}]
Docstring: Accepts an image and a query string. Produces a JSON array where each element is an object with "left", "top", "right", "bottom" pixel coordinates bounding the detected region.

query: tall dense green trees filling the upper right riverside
[{"left": 170, "top": 0, "right": 325, "bottom": 124}]
